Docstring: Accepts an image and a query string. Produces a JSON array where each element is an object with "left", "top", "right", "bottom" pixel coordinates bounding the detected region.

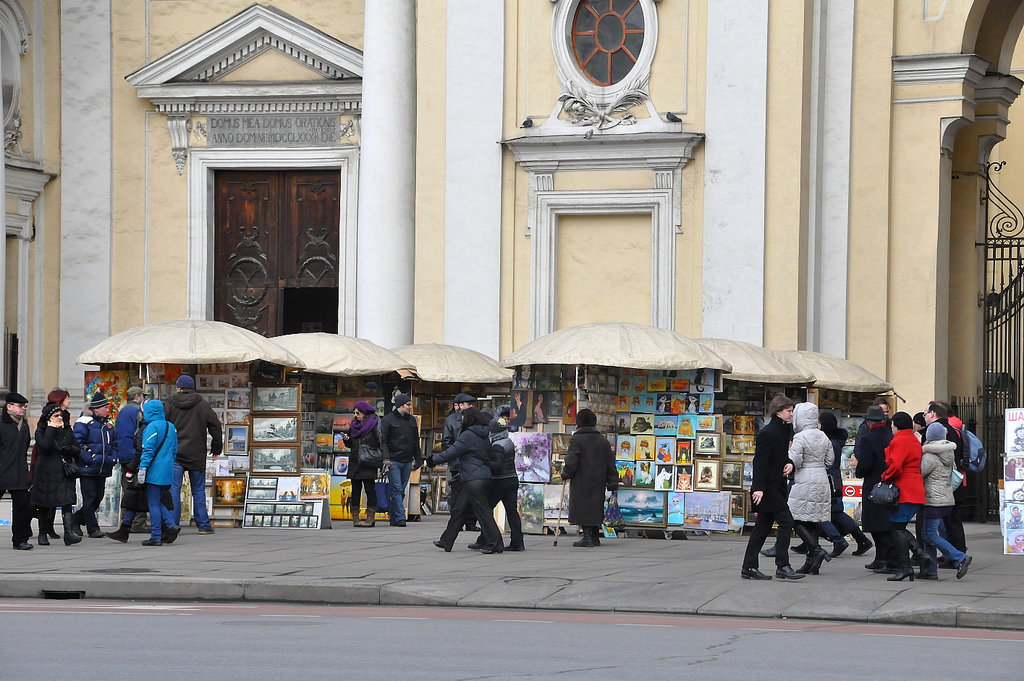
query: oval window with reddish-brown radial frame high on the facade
[{"left": 572, "top": 0, "right": 644, "bottom": 87}]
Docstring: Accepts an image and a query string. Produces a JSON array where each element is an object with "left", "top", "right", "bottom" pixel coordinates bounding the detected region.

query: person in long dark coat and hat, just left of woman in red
[{"left": 853, "top": 405, "right": 896, "bottom": 571}]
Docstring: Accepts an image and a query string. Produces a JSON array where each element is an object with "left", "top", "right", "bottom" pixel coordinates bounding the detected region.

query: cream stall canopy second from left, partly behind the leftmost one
[{"left": 272, "top": 333, "right": 413, "bottom": 376}]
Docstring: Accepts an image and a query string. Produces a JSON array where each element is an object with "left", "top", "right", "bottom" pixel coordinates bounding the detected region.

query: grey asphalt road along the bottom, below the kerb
[{"left": 0, "top": 599, "right": 1024, "bottom": 681}]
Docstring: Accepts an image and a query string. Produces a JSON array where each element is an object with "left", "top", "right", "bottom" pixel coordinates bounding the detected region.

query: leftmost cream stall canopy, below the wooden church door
[{"left": 76, "top": 320, "right": 305, "bottom": 369}]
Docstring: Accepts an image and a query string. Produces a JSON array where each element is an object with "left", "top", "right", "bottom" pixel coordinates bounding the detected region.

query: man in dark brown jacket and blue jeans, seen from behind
[{"left": 164, "top": 374, "right": 223, "bottom": 535}]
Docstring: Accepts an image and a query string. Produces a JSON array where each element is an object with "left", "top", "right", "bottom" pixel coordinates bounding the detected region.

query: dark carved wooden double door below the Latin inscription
[{"left": 214, "top": 170, "right": 340, "bottom": 336}]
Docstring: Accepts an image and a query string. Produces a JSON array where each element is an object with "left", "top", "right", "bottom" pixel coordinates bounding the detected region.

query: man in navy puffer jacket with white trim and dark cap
[{"left": 72, "top": 392, "right": 118, "bottom": 539}]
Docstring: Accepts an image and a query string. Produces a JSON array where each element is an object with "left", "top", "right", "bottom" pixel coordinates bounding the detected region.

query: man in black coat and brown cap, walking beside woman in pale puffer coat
[{"left": 739, "top": 395, "right": 804, "bottom": 580}]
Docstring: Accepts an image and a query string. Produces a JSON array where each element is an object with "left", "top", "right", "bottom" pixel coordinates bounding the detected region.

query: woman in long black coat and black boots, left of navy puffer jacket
[{"left": 32, "top": 402, "right": 82, "bottom": 546}]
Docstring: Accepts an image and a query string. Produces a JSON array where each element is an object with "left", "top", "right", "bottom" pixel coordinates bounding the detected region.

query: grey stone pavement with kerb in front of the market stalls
[{"left": 0, "top": 515, "right": 1024, "bottom": 629}]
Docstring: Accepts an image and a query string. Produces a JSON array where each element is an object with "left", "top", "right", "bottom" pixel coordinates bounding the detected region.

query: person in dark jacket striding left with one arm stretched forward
[{"left": 425, "top": 407, "right": 505, "bottom": 554}]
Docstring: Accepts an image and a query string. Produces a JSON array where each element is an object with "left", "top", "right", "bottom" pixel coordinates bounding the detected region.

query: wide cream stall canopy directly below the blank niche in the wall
[{"left": 502, "top": 322, "right": 732, "bottom": 372}]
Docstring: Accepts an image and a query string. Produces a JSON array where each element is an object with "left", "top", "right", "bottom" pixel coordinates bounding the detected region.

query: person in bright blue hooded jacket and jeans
[{"left": 138, "top": 399, "right": 181, "bottom": 546}]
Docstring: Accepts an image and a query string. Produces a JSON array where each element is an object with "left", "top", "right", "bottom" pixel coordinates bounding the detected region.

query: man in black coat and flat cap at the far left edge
[{"left": 0, "top": 392, "right": 33, "bottom": 551}]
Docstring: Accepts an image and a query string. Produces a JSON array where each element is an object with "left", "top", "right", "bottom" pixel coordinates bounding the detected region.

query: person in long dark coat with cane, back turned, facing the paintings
[{"left": 562, "top": 409, "right": 618, "bottom": 547}]
